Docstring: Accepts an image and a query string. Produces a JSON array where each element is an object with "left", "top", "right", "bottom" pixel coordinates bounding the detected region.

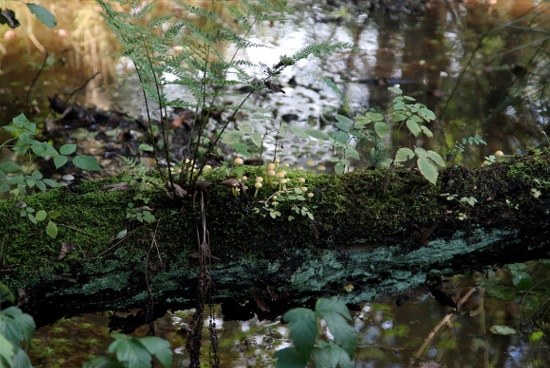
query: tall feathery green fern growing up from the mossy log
[{"left": 98, "top": 0, "right": 349, "bottom": 188}]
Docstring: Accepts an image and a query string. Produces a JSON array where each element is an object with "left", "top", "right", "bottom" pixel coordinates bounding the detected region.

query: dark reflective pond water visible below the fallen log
[{"left": 30, "top": 262, "right": 550, "bottom": 368}]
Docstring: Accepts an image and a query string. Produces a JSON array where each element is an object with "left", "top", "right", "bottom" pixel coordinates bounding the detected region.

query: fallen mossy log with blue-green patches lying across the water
[{"left": 0, "top": 150, "right": 550, "bottom": 324}]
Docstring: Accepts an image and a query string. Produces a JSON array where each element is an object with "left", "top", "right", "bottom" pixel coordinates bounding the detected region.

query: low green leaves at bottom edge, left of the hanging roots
[{"left": 84, "top": 334, "right": 172, "bottom": 368}]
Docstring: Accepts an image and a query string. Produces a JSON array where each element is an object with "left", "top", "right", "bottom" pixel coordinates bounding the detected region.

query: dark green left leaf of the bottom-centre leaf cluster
[{"left": 283, "top": 308, "right": 319, "bottom": 356}]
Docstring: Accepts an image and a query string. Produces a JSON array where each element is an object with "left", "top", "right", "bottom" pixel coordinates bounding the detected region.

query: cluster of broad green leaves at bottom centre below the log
[{"left": 275, "top": 297, "right": 357, "bottom": 368}]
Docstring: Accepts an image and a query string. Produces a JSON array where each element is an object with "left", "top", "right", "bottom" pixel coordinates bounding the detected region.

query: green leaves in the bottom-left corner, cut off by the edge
[{"left": 0, "top": 307, "right": 36, "bottom": 368}]
